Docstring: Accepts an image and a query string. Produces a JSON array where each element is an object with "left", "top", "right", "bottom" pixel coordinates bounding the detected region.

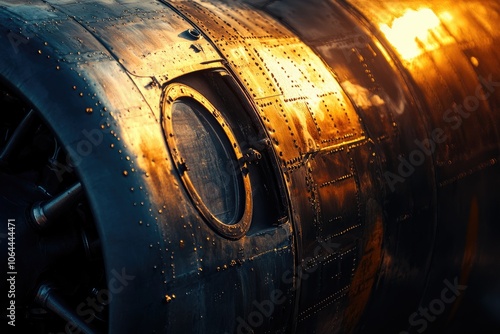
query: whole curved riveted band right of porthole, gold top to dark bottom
[{"left": 170, "top": 2, "right": 380, "bottom": 328}]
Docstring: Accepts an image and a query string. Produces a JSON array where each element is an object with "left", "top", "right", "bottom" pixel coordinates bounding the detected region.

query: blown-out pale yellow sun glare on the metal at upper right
[{"left": 380, "top": 8, "right": 443, "bottom": 60}]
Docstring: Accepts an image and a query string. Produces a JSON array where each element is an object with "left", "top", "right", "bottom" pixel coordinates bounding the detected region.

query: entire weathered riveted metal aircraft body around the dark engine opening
[{"left": 0, "top": 0, "right": 500, "bottom": 333}]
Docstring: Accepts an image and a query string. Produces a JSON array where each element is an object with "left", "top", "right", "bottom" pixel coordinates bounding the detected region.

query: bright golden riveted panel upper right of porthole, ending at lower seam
[{"left": 171, "top": 1, "right": 364, "bottom": 161}]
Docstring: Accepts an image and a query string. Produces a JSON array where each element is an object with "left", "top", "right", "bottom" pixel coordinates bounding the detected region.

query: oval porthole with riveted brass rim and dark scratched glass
[{"left": 163, "top": 84, "right": 252, "bottom": 239}]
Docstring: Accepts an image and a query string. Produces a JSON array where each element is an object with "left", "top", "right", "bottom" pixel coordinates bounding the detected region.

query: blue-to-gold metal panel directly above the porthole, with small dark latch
[{"left": 48, "top": 2, "right": 220, "bottom": 78}]
